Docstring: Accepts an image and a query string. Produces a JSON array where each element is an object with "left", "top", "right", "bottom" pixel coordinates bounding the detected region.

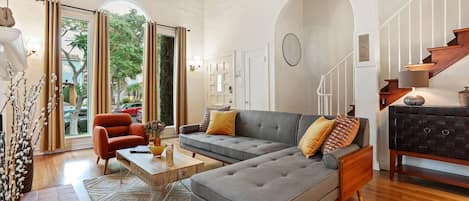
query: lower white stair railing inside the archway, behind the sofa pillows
[{"left": 316, "top": 52, "right": 355, "bottom": 115}]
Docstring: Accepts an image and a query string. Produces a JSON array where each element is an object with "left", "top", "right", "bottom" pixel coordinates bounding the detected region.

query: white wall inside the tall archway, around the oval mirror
[{"left": 274, "top": 0, "right": 353, "bottom": 114}]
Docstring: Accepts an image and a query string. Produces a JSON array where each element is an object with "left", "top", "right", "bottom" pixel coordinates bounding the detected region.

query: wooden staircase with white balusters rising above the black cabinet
[{"left": 379, "top": 0, "right": 469, "bottom": 110}]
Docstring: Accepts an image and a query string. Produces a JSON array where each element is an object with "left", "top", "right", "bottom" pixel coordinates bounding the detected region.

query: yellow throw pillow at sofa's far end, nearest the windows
[{"left": 207, "top": 111, "right": 237, "bottom": 136}]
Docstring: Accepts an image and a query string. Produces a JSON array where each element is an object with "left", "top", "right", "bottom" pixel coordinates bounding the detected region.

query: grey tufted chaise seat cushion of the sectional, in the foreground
[{"left": 191, "top": 147, "right": 339, "bottom": 201}]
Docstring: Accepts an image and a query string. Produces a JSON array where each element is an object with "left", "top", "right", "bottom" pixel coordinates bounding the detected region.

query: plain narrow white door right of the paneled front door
[{"left": 244, "top": 49, "right": 270, "bottom": 111}]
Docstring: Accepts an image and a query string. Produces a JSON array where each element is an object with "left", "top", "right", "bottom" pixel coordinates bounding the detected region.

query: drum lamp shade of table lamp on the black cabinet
[{"left": 399, "top": 71, "right": 429, "bottom": 88}]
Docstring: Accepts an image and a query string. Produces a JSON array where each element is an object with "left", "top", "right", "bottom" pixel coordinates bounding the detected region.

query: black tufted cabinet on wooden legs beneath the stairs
[{"left": 389, "top": 106, "right": 469, "bottom": 188}]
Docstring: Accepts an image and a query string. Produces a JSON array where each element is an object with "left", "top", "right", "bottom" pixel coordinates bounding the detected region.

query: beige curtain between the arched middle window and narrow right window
[{"left": 143, "top": 22, "right": 158, "bottom": 122}]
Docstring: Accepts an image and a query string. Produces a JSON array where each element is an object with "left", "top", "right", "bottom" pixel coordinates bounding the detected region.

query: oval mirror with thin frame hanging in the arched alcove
[{"left": 282, "top": 33, "right": 301, "bottom": 66}]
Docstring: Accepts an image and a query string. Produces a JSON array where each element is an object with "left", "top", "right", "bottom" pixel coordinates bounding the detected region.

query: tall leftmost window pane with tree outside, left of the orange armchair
[{"left": 61, "top": 18, "right": 90, "bottom": 136}]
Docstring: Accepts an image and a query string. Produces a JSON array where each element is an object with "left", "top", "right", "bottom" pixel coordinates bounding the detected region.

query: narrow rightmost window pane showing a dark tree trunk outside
[{"left": 158, "top": 34, "right": 174, "bottom": 126}]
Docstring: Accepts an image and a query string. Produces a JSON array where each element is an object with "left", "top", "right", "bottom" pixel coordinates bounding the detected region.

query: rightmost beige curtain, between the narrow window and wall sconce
[{"left": 176, "top": 27, "right": 187, "bottom": 134}]
